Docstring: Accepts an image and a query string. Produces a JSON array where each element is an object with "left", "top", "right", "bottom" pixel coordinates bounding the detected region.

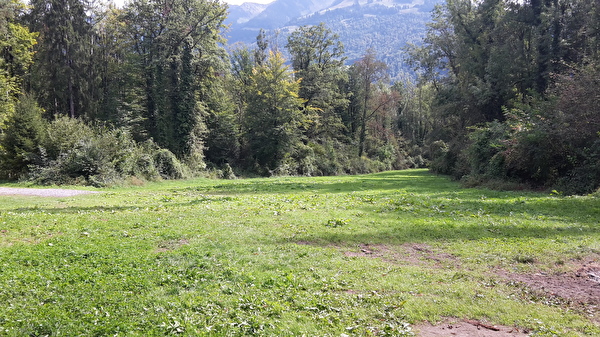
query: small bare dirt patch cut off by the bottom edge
[{"left": 413, "top": 319, "right": 528, "bottom": 337}]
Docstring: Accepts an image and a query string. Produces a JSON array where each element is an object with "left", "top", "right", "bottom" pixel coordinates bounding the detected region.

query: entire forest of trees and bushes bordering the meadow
[{"left": 0, "top": 0, "right": 600, "bottom": 194}]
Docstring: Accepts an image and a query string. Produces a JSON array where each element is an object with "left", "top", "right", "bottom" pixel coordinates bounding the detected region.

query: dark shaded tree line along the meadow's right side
[{"left": 411, "top": 0, "right": 600, "bottom": 193}]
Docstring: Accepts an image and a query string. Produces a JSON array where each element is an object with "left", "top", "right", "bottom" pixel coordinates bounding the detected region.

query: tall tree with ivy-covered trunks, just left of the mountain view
[{"left": 122, "top": 0, "right": 226, "bottom": 157}]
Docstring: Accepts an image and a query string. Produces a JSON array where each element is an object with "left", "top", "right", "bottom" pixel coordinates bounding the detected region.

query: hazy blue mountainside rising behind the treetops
[{"left": 227, "top": 0, "right": 444, "bottom": 76}]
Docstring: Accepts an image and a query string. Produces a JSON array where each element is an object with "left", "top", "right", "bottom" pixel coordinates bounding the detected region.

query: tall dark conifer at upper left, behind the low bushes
[{"left": 28, "top": 0, "right": 93, "bottom": 117}]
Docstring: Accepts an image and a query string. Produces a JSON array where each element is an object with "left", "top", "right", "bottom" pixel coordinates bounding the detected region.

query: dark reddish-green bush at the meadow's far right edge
[{"left": 506, "top": 66, "right": 600, "bottom": 193}]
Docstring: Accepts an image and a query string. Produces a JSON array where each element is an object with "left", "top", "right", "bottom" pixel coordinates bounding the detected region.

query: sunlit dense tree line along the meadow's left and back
[{"left": 0, "top": 0, "right": 423, "bottom": 185}]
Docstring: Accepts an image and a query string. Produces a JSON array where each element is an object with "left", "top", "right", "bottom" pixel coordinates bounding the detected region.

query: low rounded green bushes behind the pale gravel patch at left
[{"left": 30, "top": 117, "right": 186, "bottom": 186}]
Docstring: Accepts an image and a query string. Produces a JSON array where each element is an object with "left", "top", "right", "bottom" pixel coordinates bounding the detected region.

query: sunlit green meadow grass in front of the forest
[{"left": 0, "top": 170, "right": 600, "bottom": 336}]
